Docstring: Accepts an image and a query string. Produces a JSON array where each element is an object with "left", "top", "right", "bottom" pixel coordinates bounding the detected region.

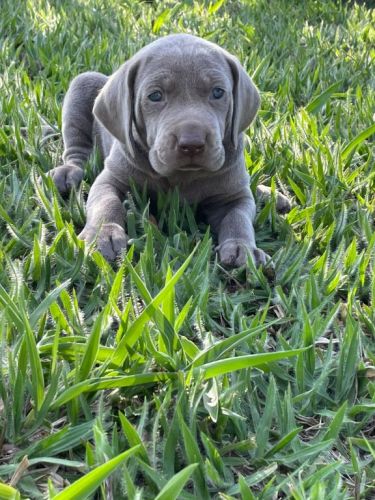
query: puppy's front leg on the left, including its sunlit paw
[{"left": 79, "top": 169, "right": 128, "bottom": 261}]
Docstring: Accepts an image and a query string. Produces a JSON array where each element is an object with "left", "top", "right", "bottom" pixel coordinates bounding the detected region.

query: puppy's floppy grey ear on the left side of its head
[{"left": 93, "top": 59, "right": 138, "bottom": 157}]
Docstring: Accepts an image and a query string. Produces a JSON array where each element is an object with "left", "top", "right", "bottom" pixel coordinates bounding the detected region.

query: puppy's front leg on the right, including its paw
[{"left": 204, "top": 194, "right": 269, "bottom": 267}]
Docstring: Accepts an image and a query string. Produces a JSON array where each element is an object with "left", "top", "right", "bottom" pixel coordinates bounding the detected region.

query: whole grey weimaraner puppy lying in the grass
[{"left": 51, "top": 34, "right": 290, "bottom": 266}]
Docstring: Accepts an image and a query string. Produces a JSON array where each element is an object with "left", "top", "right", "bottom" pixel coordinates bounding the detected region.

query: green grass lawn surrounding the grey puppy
[{"left": 0, "top": 0, "right": 375, "bottom": 500}]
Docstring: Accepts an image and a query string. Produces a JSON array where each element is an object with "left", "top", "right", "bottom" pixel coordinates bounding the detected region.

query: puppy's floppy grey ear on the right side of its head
[{"left": 227, "top": 56, "right": 260, "bottom": 148}]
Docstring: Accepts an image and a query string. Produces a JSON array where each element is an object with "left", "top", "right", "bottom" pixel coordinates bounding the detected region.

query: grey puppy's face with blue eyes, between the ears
[{"left": 134, "top": 46, "right": 233, "bottom": 176}]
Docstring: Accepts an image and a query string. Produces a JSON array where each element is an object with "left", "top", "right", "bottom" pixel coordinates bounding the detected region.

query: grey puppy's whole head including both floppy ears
[{"left": 94, "top": 35, "right": 259, "bottom": 176}]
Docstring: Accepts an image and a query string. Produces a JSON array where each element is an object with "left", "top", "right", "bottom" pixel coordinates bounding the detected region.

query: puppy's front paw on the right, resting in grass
[{"left": 217, "top": 238, "right": 270, "bottom": 267}]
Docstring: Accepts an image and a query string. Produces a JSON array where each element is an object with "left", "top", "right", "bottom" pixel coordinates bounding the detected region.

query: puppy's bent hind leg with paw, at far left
[{"left": 50, "top": 72, "right": 108, "bottom": 194}]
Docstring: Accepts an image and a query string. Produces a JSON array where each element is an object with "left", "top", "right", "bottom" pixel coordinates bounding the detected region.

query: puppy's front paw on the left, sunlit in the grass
[{"left": 79, "top": 222, "right": 128, "bottom": 261}]
